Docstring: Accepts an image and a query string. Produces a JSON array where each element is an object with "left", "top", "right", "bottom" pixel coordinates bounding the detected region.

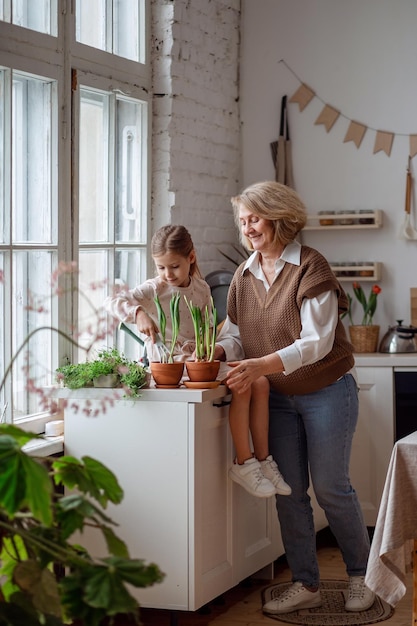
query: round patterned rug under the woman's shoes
[{"left": 262, "top": 580, "right": 394, "bottom": 626}]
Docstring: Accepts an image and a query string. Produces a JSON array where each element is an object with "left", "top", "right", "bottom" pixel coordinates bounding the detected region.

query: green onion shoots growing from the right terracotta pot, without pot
[{"left": 184, "top": 296, "right": 217, "bottom": 361}]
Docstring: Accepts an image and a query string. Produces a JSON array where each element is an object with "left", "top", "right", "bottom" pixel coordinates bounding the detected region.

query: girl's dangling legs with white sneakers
[{"left": 229, "top": 376, "right": 291, "bottom": 498}]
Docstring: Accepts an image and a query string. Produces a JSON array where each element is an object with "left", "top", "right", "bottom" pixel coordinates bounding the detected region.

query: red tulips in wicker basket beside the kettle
[{"left": 342, "top": 282, "right": 381, "bottom": 352}]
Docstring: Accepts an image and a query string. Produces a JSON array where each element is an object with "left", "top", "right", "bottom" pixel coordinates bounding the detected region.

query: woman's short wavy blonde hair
[{"left": 231, "top": 181, "right": 307, "bottom": 250}]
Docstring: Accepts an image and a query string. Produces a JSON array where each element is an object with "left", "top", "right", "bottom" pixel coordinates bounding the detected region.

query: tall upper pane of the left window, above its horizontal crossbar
[{"left": 12, "top": 74, "right": 55, "bottom": 243}]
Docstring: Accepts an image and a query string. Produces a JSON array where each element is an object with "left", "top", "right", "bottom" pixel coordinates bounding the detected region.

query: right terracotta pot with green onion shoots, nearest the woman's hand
[{"left": 185, "top": 298, "right": 220, "bottom": 382}]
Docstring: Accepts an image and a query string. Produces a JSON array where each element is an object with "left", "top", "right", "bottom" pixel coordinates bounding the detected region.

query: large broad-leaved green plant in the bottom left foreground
[{"left": 0, "top": 424, "right": 164, "bottom": 626}]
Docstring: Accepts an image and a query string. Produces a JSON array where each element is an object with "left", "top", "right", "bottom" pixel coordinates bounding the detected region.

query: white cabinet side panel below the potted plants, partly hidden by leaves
[{"left": 65, "top": 400, "right": 190, "bottom": 610}]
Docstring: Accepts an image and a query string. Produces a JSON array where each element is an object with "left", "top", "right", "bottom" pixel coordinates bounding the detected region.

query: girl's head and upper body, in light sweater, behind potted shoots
[{"left": 104, "top": 224, "right": 211, "bottom": 361}]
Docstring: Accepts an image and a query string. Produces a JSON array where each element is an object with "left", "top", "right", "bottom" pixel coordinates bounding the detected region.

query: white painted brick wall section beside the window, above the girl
[{"left": 151, "top": 0, "right": 240, "bottom": 274}]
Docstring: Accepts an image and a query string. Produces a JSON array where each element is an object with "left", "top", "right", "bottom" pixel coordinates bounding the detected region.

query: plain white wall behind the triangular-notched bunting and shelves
[{"left": 240, "top": 0, "right": 417, "bottom": 335}]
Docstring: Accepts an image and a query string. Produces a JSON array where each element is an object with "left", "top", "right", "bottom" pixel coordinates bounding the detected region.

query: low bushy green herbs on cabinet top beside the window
[{"left": 56, "top": 348, "right": 147, "bottom": 397}]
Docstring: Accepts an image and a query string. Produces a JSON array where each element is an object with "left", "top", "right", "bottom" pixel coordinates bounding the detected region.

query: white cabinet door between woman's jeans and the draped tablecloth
[{"left": 350, "top": 367, "right": 394, "bottom": 526}]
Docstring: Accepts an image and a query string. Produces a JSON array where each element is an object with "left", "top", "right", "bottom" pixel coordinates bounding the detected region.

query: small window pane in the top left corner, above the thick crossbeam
[{"left": 0, "top": 0, "right": 57, "bottom": 36}]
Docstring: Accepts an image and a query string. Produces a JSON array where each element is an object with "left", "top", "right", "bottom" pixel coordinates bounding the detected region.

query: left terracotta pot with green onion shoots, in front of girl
[{"left": 151, "top": 292, "right": 184, "bottom": 388}]
